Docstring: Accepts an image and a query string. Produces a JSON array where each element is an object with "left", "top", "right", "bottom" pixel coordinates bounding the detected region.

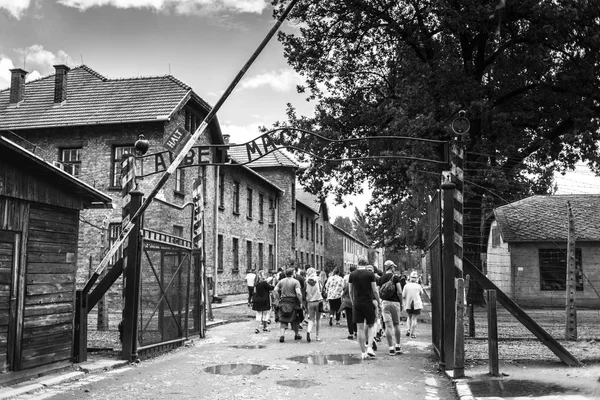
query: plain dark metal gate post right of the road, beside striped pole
[{"left": 441, "top": 182, "right": 456, "bottom": 370}]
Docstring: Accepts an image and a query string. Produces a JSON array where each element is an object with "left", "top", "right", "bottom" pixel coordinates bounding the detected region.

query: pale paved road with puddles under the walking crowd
[{"left": 12, "top": 320, "right": 456, "bottom": 400}]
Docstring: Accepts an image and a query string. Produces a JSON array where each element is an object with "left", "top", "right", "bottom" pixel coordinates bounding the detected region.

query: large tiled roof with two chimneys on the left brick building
[{"left": 0, "top": 65, "right": 223, "bottom": 143}]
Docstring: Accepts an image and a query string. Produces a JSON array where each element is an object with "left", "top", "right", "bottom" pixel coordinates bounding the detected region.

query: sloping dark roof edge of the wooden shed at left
[{"left": 0, "top": 136, "right": 112, "bottom": 208}]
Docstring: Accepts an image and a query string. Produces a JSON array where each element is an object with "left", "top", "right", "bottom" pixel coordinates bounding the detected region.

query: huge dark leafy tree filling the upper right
[{"left": 273, "top": 0, "right": 600, "bottom": 288}]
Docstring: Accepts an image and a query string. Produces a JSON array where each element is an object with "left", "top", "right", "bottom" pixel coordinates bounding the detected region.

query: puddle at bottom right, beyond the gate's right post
[{"left": 469, "top": 380, "right": 578, "bottom": 397}]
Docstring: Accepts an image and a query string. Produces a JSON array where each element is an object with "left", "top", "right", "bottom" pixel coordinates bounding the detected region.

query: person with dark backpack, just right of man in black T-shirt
[{"left": 379, "top": 260, "right": 402, "bottom": 356}]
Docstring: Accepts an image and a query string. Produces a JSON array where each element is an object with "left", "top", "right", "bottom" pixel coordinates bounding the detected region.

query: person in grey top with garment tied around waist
[{"left": 274, "top": 268, "right": 302, "bottom": 343}]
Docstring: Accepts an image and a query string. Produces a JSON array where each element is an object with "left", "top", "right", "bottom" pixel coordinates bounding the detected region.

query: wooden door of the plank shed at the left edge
[{"left": 0, "top": 230, "right": 19, "bottom": 372}]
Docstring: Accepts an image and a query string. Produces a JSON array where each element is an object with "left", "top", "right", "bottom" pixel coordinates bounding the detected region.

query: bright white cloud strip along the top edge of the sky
[{"left": 57, "top": 0, "right": 268, "bottom": 14}]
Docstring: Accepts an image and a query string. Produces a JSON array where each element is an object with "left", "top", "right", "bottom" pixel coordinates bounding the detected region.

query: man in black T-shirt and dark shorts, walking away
[{"left": 348, "top": 258, "right": 380, "bottom": 360}]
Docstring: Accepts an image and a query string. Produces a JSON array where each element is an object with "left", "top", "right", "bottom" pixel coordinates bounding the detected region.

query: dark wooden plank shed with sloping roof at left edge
[{"left": 0, "top": 136, "right": 111, "bottom": 383}]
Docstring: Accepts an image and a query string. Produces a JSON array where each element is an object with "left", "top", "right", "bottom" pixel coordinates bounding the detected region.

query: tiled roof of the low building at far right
[{"left": 494, "top": 194, "right": 600, "bottom": 242}]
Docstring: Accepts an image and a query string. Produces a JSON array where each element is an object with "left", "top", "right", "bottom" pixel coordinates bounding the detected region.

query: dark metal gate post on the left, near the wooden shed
[{"left": 121, "top": 190, "right": 144, "bottom": 361}]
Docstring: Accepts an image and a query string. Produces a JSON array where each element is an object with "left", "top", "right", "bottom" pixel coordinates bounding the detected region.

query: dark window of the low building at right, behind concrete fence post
[{"left": 539, "top": 249, "right": 583, "bottom": 291}]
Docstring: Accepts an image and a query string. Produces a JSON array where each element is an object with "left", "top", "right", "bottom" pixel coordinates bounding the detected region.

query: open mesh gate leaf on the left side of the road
[{"left": 138, "top": 229, "right": 204, "bottom": 353}]
